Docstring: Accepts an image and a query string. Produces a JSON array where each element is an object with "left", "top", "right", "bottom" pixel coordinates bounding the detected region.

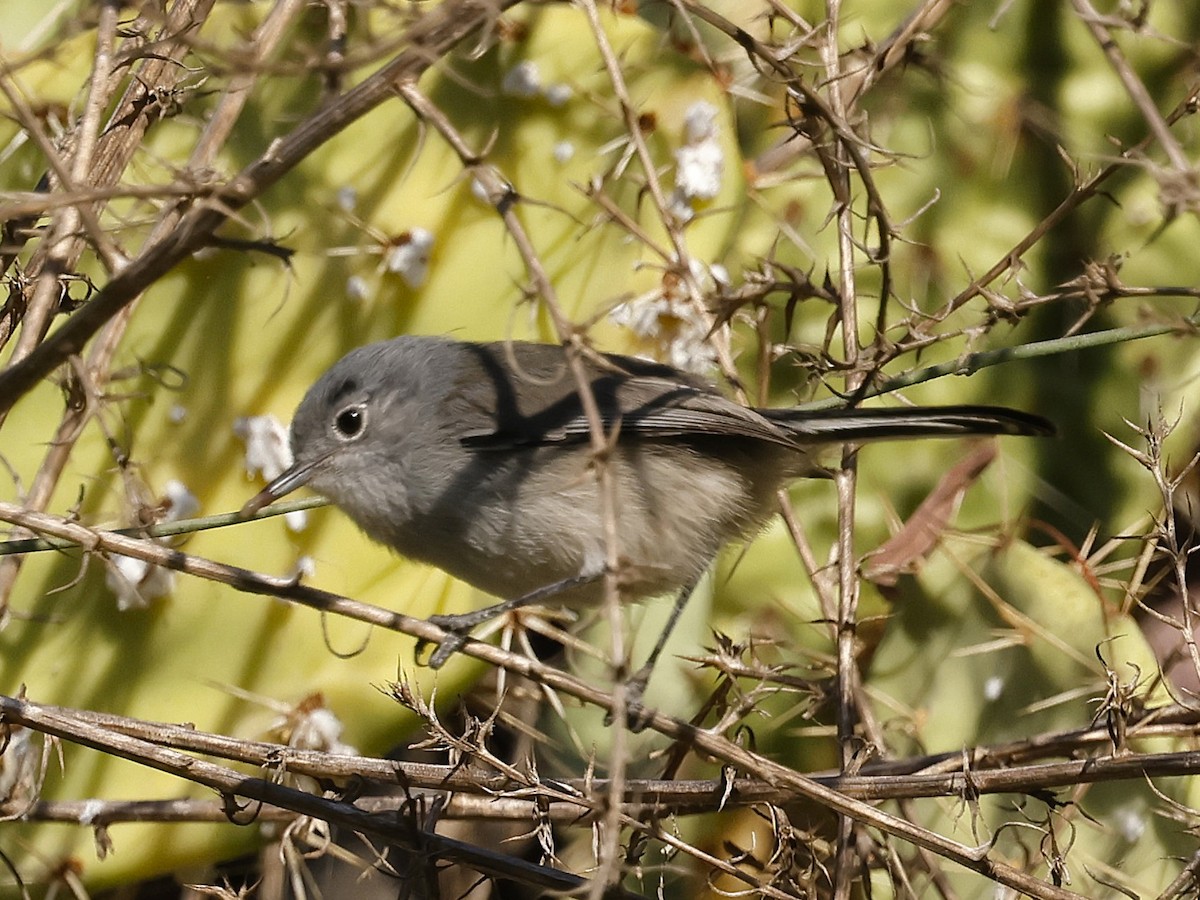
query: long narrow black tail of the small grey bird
[{"left": 758, "top": 406, "right": 1055, "bottom": 444}]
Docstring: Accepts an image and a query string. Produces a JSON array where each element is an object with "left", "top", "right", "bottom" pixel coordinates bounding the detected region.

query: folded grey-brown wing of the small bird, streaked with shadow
[{"left": 446, "top": 341, "right": 794, "bottom": 450}]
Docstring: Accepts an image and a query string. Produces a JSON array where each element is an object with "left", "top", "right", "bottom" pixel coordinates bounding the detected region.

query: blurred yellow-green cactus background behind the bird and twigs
[{"left": 0, "top": 0, "right": 1200, "bottom": 898}]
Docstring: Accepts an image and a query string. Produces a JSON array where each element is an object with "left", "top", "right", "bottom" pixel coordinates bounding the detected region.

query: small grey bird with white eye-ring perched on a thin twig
[{"left": 242, "top": 336, "right": 1054, "bottom": 683}]
